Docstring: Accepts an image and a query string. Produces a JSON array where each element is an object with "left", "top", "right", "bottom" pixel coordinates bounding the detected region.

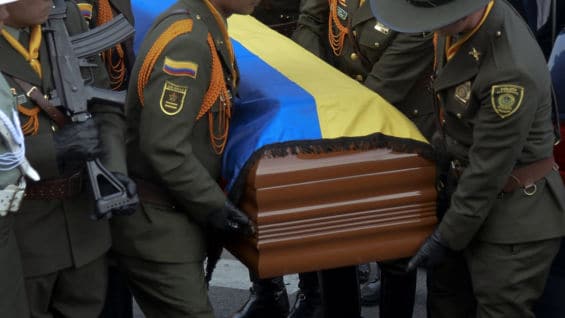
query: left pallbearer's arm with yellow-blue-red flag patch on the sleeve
[{"left": 138, "top": 31, "right": 226, "bottom": 222}]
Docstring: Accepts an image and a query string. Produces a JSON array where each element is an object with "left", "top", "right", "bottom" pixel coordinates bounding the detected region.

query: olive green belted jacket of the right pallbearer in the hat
[{"left": 433, "top": 1, "right": 565, "bottom": 250}]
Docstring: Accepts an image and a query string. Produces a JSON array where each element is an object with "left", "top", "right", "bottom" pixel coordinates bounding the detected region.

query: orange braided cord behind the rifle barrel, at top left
[{"left": 96, "top": 0, "right": 126, "bottom": 89}]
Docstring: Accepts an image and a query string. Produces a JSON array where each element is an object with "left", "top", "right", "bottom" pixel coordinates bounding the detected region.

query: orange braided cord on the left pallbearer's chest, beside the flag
[{"left": 196, "top": 34, "right": 231, "bottom": 155}]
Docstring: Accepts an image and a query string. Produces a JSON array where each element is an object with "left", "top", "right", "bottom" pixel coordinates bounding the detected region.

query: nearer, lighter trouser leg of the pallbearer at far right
[{"left": 465, "top": 238, "right": 561, "bottom": 318}]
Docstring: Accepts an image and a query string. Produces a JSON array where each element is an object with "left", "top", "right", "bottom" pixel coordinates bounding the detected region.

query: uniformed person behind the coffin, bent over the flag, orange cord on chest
[{"left": 280, "top": 0, "right": 435, "bottom": 318}]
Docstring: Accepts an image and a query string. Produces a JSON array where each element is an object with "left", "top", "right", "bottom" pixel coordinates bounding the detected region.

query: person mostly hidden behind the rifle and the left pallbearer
[{"left": 77, "top": 0, "right": 135, "bottom": 318}]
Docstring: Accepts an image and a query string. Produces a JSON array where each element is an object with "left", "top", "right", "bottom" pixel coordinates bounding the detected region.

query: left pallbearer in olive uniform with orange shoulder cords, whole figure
[{"left": 112, "top": 0, "right": 257, "bottom": 318}]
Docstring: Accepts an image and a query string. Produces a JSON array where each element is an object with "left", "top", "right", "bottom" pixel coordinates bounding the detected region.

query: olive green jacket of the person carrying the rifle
[{"left": 0, "top": 2, "right": 126, "bottom": 277}]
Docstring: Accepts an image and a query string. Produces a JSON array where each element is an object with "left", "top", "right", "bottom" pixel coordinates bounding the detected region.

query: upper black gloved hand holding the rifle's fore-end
[{"left": 54, "top": 118, "right": 101, "bottom": 162}]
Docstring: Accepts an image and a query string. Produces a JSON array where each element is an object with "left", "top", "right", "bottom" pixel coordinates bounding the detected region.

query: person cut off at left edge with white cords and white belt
[{"left": 0, "top": 0, "right": 38, "bottom": 317}]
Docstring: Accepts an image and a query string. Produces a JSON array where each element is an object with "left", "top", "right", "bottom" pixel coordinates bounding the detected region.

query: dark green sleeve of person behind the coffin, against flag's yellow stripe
[{"left": 365, "top": 31, "right": 433, "bottom": 106}]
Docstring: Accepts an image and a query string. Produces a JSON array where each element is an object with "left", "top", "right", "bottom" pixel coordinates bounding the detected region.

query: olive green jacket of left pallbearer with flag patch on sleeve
[{"left": 112, "top": 0, "right": 235, "bottom": 263}]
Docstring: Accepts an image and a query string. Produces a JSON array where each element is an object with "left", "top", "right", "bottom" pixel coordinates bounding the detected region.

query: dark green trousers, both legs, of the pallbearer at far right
[{"left": 427, "top": 238, "right": 561, "bottom": 318}]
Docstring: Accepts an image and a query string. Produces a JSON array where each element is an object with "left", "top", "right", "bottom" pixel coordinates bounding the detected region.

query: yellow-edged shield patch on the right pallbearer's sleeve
[{"left": 490, "top": 84, "right": 524, "bottom": 118}]
